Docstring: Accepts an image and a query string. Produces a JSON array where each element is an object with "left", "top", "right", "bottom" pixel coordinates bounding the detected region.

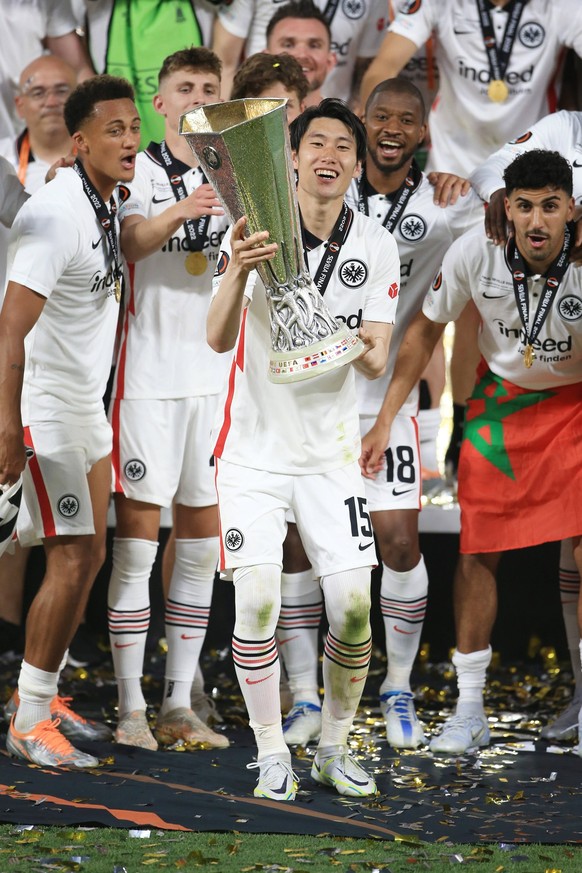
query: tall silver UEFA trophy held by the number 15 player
[{"left": 180, "top": 98, "right": 364, "bottom": 382}]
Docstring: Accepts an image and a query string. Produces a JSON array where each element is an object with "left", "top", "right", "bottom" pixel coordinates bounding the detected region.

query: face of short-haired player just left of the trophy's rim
[{"left": 153, "top": 67, "right": 220, "bottom": 132}]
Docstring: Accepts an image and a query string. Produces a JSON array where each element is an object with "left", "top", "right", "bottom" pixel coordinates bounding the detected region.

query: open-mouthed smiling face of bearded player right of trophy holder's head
[{"left": 365, "top": 91, "right": 426, "bottom": 174}]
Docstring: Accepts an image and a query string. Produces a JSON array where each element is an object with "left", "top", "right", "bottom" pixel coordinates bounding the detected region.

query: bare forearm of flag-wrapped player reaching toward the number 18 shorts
[{"left": 360, "top": 312, "right": 446, "bottom": 479}]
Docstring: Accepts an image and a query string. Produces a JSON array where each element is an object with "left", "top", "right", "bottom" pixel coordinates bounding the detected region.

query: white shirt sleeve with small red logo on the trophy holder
[{"left": 363, "top": 219, "right": 400, "bottom": 324}]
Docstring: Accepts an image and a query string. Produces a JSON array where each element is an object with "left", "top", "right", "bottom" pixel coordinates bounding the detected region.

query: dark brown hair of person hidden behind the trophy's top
[{"left": 230, "top": 52, "right": 309, "bottom": 103}]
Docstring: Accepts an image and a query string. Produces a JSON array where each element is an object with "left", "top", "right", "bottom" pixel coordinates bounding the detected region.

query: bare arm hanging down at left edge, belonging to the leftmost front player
[{"left": 0, "top": 282, "right": 46, "bottom": 485}]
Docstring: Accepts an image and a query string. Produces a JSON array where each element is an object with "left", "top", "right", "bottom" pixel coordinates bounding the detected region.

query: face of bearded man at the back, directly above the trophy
[{"left": 267, "top": 18, "right": 336, "bottom": 91}]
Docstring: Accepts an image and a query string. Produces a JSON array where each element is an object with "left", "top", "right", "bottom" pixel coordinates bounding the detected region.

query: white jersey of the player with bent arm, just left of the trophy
[{"left": 113, "top": 151, "right": 231, "bottom": 400}]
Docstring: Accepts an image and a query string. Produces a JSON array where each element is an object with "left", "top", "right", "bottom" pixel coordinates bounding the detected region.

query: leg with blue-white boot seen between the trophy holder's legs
[{"left": 277, "top": 523, "right": 323, "bottom": 745}]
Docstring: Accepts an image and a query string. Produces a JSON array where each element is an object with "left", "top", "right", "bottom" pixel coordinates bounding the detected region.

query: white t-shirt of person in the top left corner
[{"left": 0, "top": 0, "right": 76, "bottom": 137}]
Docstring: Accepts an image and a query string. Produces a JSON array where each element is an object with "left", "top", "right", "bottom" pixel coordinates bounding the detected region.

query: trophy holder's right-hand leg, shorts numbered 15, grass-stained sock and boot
[{"left": 293, "top": 464, "right": 376, "bottom": 796}]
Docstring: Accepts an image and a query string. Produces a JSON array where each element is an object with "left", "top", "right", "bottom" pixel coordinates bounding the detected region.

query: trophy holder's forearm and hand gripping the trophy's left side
[{"left": 206, "top": 216, "right": 279, "bottom": 352}]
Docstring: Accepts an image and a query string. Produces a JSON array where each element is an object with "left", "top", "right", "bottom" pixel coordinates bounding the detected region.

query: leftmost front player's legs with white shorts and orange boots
[{"left": 7, "top": 422, "right": 111, "bottom": 767}]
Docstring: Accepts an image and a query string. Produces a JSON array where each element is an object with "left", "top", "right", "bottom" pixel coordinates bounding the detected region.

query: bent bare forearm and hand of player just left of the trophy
[{"left": 121, "top": 183, "right": 224, "bottom": 264}]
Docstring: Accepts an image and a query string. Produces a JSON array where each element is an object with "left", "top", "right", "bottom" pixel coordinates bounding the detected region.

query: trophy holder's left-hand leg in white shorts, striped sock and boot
[{"left": 216, "top": 460, "right": 297, "bottom": 800}]
